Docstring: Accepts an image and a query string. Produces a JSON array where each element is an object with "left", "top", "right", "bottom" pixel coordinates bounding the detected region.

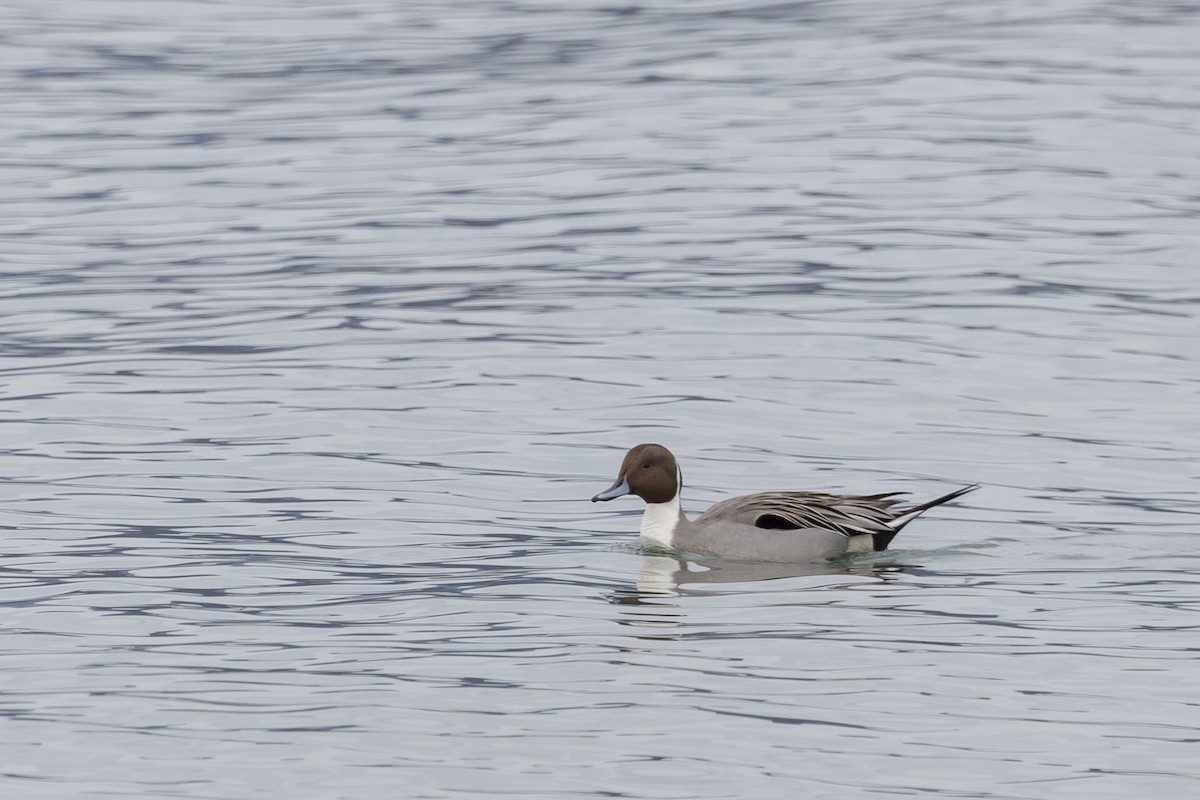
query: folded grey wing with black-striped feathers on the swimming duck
[{"left": 696, "top": 492, "right": 907, "bottom": 536}]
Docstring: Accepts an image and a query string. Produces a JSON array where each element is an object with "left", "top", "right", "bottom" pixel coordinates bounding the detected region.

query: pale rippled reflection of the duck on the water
[{"left": 610, "top": 555, "right": 905, "bottom": 638}]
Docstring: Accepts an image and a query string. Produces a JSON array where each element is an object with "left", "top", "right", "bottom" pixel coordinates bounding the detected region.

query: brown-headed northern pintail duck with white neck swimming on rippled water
[{"left": 592, "top": 444, "right": 978, "bottom": 561}]
